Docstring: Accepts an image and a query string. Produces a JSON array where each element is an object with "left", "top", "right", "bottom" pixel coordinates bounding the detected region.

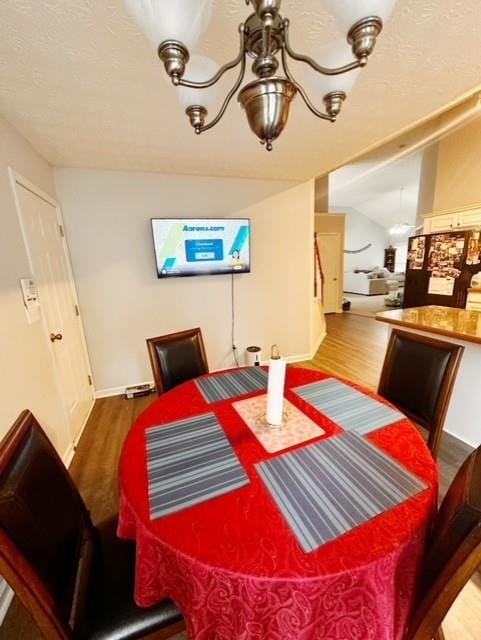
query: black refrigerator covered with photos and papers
[{"left": 403, "top": 229, "right": 481, "bottom": 308}]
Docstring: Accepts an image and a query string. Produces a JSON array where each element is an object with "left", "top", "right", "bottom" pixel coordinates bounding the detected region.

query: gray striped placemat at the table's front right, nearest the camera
[{"left": 256, "top": 433, "right": 427, "bottom": 553}]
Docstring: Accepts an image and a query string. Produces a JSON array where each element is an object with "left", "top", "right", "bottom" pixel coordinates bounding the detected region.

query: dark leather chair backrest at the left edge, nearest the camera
[{"left": 0, "top": 411, "right": 95, "bottom": 640}]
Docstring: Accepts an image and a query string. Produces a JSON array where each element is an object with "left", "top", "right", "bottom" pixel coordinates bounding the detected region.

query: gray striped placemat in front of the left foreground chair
[{"left": 146, "top": 413, "right": 249, "bottom": 519}]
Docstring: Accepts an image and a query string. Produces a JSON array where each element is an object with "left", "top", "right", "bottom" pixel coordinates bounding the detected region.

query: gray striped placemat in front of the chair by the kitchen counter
[{"left": 293, "top": 378, "right": 405, "bottom": 434}]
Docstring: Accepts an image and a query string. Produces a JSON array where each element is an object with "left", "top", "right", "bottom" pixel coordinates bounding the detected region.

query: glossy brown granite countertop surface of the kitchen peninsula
[{"left": 376, "top": 306, "right": 481, "bottom": 344}]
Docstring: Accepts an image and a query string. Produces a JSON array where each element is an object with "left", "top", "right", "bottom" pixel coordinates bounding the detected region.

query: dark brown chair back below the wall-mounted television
[{"left": 147, "top": 328, "right": 209, "bottom": 396}]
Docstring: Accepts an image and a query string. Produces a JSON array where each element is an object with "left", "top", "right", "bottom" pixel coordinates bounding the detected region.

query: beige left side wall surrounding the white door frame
[{"left": 0, "top": 117, "right": 71, "bottom": 456}]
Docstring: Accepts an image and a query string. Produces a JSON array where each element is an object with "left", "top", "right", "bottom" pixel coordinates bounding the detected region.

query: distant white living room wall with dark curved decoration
[{"left": 331, "top": 208, "right": 389, "bottom": 271}]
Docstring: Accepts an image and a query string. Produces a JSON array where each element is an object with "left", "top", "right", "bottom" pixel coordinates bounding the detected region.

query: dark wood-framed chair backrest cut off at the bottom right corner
[{"left": 406, "top": 447, "right": 481, "bottom": 640}]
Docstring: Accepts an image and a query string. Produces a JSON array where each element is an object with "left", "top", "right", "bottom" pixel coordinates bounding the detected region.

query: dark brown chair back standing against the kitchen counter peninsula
[{"left": 378, "top": 329, "right": 464, "bottom": 458}]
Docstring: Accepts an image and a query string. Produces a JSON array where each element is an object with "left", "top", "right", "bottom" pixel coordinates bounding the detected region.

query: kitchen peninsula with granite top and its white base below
[{"left": 376, "top": 306, "right": 481, "bottom": 447}]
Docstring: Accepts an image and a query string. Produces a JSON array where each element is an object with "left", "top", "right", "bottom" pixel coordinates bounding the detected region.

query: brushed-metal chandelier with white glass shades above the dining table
[{"left": 126, "top": 0, "right": 396, "bottom": 151}]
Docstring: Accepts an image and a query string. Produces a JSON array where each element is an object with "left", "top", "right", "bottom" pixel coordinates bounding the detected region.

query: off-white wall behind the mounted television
[{"left": 55, "top": 169, "right": 308, "bottom": 393}]
